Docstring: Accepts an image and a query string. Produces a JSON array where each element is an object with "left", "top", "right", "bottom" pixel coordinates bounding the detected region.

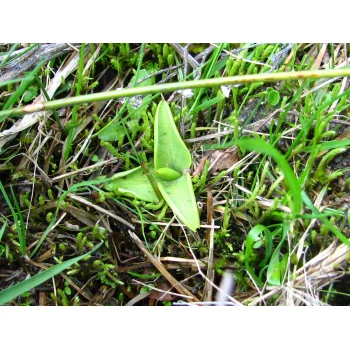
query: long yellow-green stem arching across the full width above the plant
[{"left": 0, "top": 68, "right": 350, "bottom": 118}]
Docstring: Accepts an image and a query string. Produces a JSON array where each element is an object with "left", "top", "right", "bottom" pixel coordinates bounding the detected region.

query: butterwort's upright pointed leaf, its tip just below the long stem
[{"left": 154, "top": 101, "right": 192, "bottom": 174}]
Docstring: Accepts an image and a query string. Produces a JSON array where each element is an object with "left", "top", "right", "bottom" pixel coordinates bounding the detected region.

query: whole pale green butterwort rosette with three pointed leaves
[{"left": 105, "top": 100, "right": 200, "bottom": 231}]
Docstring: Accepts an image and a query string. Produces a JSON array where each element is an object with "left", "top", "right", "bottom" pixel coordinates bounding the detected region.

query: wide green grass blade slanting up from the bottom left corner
[{"left": 0, "top": 242, "right": 103, "bottom": 305}]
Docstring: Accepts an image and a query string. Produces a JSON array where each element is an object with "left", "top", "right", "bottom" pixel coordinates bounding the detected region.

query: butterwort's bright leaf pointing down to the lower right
[{"left": 158, "top": 173, "right": 200, "bottom": 231}]
